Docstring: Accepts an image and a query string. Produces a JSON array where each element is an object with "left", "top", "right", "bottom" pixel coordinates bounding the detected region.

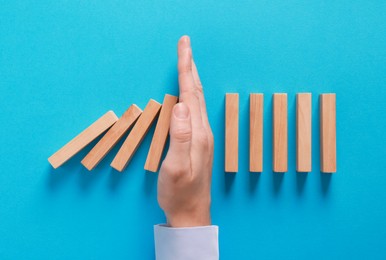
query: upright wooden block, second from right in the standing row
[{"left": 296, "top": 93, "right": 312, "bottom": 172}]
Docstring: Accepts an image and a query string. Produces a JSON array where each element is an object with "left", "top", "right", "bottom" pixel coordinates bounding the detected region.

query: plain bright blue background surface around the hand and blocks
[{"left": 0, "top": 0, "right": 386, "bottom": 259}]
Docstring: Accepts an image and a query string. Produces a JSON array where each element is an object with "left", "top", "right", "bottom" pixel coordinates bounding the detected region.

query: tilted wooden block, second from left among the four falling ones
[{"left": 82, "top": 104, "right": 142, "bottom": 171}]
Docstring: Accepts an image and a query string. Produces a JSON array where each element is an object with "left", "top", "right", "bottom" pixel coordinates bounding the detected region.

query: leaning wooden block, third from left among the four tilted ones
[{"left": 111, "top": 99, "right": 161, "bottom": 172}]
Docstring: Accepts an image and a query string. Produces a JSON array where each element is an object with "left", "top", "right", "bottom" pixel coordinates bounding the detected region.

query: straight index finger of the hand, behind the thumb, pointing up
[{"left": 178, "top": 36, "right": 202, "bottom": 128}]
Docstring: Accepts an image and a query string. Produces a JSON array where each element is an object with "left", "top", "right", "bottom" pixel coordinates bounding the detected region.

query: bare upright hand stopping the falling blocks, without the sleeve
[{"left": 158, "top": 36, "right": 213, "bottom": 227}]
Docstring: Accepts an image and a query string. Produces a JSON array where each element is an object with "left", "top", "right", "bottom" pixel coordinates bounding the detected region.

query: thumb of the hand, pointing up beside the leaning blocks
[{"left": 168, "top": 102, "right": 192, "bottom": 160}]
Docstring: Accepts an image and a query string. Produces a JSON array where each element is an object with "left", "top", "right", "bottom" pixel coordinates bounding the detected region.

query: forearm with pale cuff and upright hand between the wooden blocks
[{"left": 154, "top": 36, "right": 219, "bottom": 260}]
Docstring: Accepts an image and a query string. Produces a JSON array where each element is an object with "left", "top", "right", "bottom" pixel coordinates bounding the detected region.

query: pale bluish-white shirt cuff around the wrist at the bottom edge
[{"left": 154, "top": 225, "right": 219, "bottom": 260}]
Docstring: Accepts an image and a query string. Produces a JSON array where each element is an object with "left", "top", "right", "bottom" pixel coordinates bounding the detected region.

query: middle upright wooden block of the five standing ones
[{"left": 273, "top": 93, "right": 288, "bottom": 172}]
